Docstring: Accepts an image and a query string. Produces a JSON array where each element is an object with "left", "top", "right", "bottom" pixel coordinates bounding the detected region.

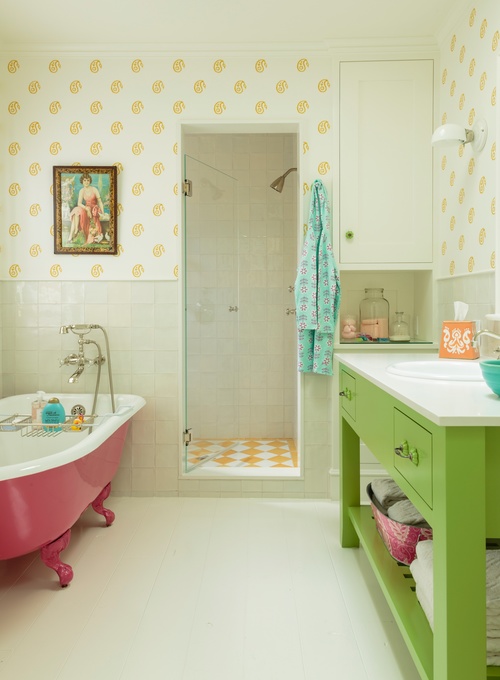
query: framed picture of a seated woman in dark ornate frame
[{"left": 53, "top": 165, "right": 118, "bottom": 255}]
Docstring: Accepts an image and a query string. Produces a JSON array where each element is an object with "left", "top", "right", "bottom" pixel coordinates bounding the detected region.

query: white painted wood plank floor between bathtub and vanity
[{"left": 0, "top": 498, "right": 419, "bottom": 680}]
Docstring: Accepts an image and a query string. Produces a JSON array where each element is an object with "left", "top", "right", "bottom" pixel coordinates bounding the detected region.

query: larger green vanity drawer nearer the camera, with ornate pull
[{"left": 393, "top": 408, "right": 432, "bottom": 508}]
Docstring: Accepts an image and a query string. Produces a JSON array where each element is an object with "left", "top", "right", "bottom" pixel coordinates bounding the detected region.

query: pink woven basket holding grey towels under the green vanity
[{"left": 366, "top": 484, "right": 432, "bottom": 566}]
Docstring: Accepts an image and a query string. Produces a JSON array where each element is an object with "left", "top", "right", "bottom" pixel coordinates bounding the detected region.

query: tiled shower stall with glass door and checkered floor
[{"left": 183, "top": 134, "right": 299, "bottom": 476}]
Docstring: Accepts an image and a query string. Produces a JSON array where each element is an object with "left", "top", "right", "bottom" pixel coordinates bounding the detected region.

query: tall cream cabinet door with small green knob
[{"left": 339, "top": 59, "right": 433, "bottom": 264}]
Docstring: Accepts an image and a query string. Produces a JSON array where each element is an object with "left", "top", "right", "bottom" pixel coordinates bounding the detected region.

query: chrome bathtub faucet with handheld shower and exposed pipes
[{"left": 59, "top": 323, "right": 115, "bottom": 413}]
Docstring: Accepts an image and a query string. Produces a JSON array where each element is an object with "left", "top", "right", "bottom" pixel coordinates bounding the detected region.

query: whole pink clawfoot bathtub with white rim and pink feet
[{"left": 0, "top": 394, "right": 145, "bottom": 587}]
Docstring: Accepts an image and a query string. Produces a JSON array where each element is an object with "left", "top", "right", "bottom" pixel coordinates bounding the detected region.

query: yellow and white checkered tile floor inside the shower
[{"left": 188, "top": 439, "right": 298, "bottom": 468}]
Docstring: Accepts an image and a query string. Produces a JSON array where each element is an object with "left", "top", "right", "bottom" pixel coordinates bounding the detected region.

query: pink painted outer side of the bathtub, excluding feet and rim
[{"left": 0, "top": 421, "right": 130, "bottom": 560}]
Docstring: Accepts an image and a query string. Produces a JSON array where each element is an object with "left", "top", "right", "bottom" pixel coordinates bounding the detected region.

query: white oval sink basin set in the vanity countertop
[{"left": 387, "top": 359, "right": 483, "bottom": 382}]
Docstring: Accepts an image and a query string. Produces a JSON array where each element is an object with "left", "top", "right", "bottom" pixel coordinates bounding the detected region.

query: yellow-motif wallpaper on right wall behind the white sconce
[{"left": 434, "top": 0, "right": 500, "bottom": 276}]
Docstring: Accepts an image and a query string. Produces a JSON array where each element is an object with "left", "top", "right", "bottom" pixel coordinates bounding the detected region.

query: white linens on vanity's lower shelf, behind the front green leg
[{"left": 410, "top": 541, "right": 500, "bottom": 666}]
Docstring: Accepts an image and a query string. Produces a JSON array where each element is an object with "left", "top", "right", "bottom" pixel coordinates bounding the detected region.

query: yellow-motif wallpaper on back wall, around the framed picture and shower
[{"left": 0, "top": 53, "right": 335, "bottom": 280}]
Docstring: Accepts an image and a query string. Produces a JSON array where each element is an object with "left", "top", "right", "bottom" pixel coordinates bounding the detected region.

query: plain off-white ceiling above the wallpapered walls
[{"left": 0, "top": 0, "right": 468, "bottom": 50}]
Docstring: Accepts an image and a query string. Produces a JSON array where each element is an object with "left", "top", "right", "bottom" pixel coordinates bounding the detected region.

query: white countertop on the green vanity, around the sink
[{"left": 334, "top": 352, "right": 500, "bottom": 426}]
